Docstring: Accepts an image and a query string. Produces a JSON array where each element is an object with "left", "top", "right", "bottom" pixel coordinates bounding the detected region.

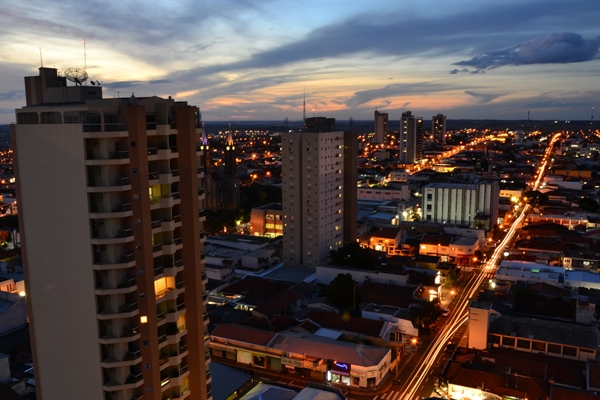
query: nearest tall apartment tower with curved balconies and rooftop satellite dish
[{"left": 11, "top": 68, "right": 212, "bottom": 400}]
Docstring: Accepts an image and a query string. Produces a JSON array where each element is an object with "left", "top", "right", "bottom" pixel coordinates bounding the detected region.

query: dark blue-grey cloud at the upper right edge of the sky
[{"left": 451, "top": 32, "right": 600, "bottom": 73}]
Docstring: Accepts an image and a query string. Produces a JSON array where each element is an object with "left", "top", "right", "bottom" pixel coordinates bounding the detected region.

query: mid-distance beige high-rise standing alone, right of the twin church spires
[{"left": 281, "top": 117, "right": 357, "bottom": 268}]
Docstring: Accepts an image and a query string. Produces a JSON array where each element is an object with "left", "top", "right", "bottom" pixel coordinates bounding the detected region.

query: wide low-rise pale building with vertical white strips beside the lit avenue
[{"left": 423, "top": 181, "right": 500, "bottom": 229}]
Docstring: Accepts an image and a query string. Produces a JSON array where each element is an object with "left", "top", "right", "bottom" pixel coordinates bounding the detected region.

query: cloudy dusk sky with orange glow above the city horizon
[{"left": 0, "top": 0, "right": 600, "bottom": 124}]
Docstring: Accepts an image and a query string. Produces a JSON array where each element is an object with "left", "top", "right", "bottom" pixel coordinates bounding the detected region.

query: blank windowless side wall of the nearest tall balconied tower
[{"left": 12, "top": 124, "right": 102, "bottom": 399}]
